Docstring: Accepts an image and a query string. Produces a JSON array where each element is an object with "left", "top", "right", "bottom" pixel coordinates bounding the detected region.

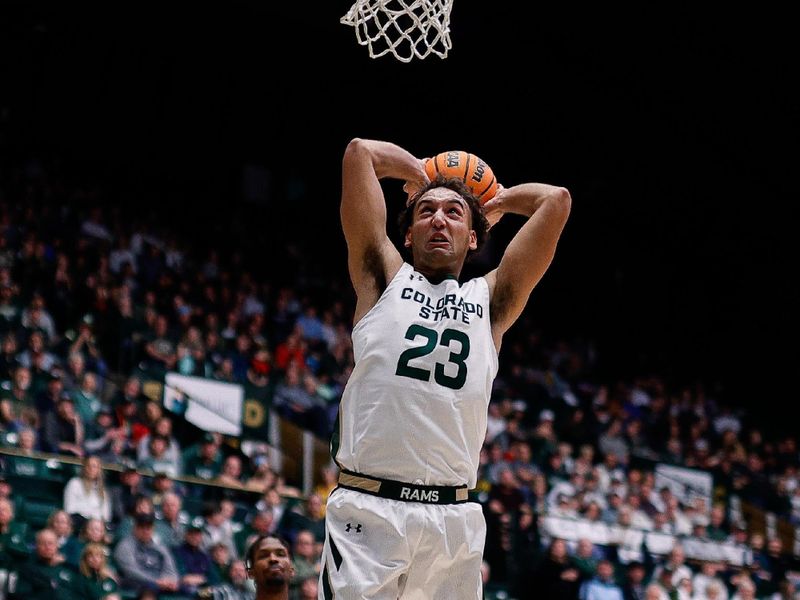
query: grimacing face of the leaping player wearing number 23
[{"left": 405, "top": 187, "right": 478, "bottom": 265}]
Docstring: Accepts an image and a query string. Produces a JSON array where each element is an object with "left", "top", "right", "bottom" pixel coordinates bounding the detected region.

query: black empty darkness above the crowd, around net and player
[{"left": 0, "top": 0, "right": 798, "bottom": 418}]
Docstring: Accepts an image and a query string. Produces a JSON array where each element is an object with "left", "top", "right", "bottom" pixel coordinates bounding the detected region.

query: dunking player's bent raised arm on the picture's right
[{"left": 484, "top": 183, "right": 572, "bottom": 348}]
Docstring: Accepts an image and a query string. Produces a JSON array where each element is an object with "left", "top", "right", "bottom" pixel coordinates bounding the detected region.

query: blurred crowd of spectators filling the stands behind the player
[{"left": 0, "top": 161, "right": 800, "bottom": 600}]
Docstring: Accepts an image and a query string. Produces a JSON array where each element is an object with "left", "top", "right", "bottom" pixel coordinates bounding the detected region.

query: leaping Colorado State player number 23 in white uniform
[{"left": 319, "top": 139, "right": 571, "bottom": 600}]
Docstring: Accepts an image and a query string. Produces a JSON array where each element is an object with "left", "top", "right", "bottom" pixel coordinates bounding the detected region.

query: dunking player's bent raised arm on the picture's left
[{"left": 340, "top": 139, "right": 427, "bottom": 322}]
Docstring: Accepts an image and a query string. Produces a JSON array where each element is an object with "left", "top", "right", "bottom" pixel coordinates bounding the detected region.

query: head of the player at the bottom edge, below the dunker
[{"left": 245, "top": 535, "right": 294, "bottom": 600}]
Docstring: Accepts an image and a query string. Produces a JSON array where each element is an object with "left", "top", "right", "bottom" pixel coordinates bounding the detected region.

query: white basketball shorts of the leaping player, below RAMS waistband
[{"left": 319, "top": 488, "right": 486, "bottom": 600}]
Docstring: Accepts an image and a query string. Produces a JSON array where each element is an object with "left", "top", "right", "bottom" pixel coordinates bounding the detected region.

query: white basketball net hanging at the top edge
[{"left": 340, "top": 0, "right": 453, "bottom": 62}]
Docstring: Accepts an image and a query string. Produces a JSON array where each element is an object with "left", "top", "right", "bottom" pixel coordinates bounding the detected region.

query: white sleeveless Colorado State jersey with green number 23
[{"left": 331, "top": 263, "right": 497, "bottom": 488}]
